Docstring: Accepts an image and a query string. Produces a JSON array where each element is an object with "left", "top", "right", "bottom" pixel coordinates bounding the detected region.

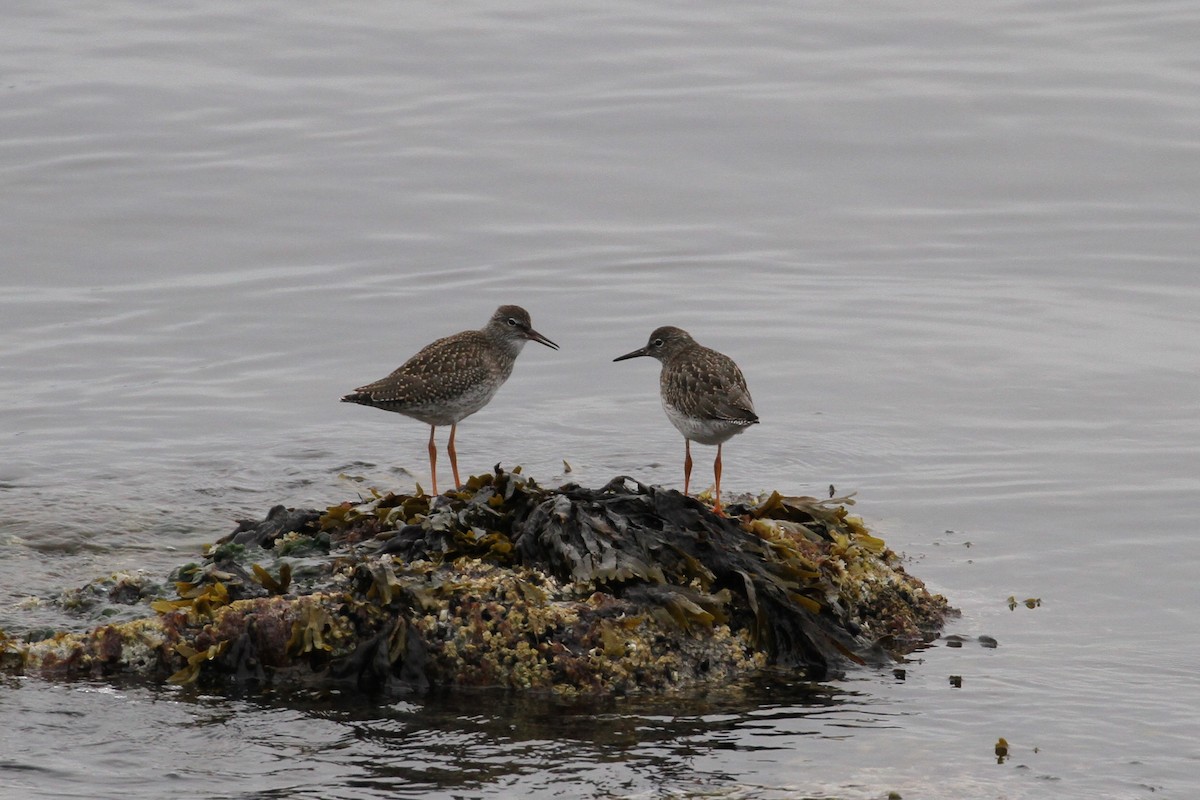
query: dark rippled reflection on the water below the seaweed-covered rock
[{"left": 213, "top": 678, "right": 864, "bottom": 796}]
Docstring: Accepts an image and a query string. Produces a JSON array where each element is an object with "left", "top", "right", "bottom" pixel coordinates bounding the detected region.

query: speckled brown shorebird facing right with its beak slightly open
[{"left": 342, "top": 306, "right": 558, "bottom": 495}]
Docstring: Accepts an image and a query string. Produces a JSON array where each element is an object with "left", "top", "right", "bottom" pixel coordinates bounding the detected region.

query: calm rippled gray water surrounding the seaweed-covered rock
[{"left": 0, "top": 0, "right": 1200, "bottom": 800}]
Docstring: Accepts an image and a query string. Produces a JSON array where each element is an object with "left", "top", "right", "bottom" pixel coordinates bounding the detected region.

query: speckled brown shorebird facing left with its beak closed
[{"left": 613, "top": 325, "right": 758, "bottom": 513}]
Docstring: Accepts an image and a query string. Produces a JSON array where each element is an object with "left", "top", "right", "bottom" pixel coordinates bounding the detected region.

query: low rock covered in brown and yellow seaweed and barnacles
[{"left": 0, "top": 468, "right": 949, "bottom": 694}]
